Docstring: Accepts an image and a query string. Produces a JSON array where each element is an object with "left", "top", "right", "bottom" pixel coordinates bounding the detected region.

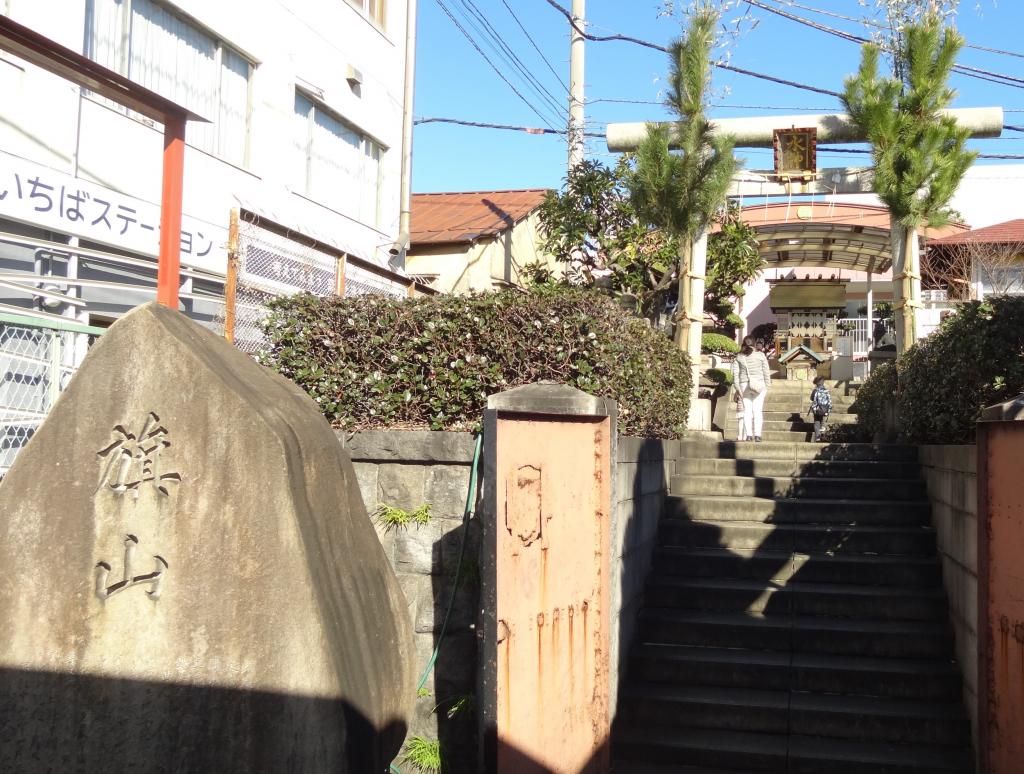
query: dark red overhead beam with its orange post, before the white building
[{"left": 0, "top": 15, "right": 207, "bottom": 309}]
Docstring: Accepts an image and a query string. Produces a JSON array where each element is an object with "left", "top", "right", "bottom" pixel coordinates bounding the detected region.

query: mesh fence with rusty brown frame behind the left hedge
[{"left": 227, "top": 214, "right": 409, "bottom": 354}]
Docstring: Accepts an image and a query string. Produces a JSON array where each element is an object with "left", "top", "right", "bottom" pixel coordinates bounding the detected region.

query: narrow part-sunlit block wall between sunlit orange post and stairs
[{"left": 609, "top": 436, "right": 680, "bottom": 712}]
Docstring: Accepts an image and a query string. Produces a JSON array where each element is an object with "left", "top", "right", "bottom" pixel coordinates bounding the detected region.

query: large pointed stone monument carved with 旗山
[{"left": 0, "top": 304, "right": 415, "bottom": 774}]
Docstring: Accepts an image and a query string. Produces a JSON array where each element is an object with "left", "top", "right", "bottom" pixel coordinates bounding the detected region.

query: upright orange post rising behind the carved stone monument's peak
[{"left": 157, "top": 116, "right": 185, "bottom": 309}]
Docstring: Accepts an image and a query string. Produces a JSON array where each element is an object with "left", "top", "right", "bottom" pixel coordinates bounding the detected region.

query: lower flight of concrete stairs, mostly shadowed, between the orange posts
[{"left": 612, "top": 438, "right": 973, "bottom": 774}]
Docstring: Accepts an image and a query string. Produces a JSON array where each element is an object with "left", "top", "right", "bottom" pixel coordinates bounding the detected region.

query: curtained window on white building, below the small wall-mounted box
[{"left": 294, "top": 91, "right": 383, "bottom": 228}]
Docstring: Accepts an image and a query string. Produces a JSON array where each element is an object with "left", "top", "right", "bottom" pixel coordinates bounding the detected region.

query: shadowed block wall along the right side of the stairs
[{"left": 921, "top": 445, "right": 978, "bottom": 742}]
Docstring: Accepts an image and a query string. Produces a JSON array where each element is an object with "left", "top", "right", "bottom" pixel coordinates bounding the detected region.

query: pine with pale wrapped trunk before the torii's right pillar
[{"left": 843, "top": 14, "right": 977, "bottom": 352}]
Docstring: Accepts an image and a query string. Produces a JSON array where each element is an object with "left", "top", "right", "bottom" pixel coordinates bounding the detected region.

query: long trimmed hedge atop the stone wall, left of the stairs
[{"left": 261, "top": 289, "right": 692, "bottom": 438}]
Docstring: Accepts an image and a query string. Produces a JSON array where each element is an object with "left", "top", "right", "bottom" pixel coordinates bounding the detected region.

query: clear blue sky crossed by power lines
[{"left": 413, "top": 0, "right": 1024, "bottom": 191}]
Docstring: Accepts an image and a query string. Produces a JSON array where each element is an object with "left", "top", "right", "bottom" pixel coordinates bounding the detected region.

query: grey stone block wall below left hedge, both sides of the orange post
[{"left": 339, "top": 431, "right": 680, "bottom": 771}]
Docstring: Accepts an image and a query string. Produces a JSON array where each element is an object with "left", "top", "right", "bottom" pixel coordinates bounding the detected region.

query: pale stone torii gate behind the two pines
[{"left": 606, "top": 108, "right": 1002, "bottom": 429}]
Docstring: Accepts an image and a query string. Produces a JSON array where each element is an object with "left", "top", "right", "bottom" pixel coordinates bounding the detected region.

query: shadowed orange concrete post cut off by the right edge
[{"left": 978, "top": 395, "right": 1024, "bottom": 774}]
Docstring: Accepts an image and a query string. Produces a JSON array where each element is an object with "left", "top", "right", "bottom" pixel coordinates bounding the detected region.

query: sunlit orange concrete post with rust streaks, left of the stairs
[{"left": 478, "top": 384, "right": 615, "bottom": 774}]
